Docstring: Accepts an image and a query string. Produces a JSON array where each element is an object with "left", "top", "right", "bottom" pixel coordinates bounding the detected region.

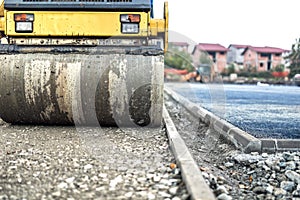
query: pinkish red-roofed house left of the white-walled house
[{"left": 192, "top": 43, "right": 228, "bottom": 79}]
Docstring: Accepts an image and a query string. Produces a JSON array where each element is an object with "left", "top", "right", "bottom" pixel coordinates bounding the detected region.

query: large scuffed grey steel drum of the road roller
[{"left": 0, "top": 47, "right": 163, "bottom": 127}]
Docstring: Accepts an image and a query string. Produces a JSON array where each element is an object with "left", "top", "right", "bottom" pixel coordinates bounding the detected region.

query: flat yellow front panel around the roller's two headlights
[{"left": 5, "top": 11, "right": 149, "bottom": 37}]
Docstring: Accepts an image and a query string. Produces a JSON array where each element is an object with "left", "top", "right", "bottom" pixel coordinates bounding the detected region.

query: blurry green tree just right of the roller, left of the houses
[{"left": 165, "top": 46, "right": 195, "bottom": 72}]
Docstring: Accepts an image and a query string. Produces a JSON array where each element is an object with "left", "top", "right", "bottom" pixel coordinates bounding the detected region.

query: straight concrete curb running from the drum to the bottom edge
[{"left": 163, "top": 106, "right": 215, "bottom": 200}]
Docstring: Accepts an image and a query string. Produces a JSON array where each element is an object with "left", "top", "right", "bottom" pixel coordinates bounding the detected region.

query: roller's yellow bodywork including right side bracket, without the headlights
[{"left": 0, "top": 0, "right": 168, "bottom": 48}]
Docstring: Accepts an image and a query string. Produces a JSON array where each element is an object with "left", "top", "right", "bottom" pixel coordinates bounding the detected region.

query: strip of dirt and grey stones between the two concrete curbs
[{"left": 165, "top": 96, "right": 300, "bottom": 200}]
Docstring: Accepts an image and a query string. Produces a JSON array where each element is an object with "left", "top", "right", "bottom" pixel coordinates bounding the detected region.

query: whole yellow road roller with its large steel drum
[{"left": 0, "top": 0, "right": 168, "bottom": 127}]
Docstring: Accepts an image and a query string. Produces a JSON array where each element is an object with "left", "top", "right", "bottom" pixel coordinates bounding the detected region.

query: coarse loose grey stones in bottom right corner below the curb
[{"left": 224, "top": 152, "right": 300, "bottom": 200}]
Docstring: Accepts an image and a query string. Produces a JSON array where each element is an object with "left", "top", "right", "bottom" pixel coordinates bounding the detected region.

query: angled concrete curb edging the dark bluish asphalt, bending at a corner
[{"left": 165, "top": 87, "right": 300, "bottom": 153}]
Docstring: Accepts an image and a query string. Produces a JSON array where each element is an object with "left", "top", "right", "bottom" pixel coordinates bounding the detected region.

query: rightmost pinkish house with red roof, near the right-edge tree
[{"left": 242, "top": 46, "right": 288, "bottom": 71}]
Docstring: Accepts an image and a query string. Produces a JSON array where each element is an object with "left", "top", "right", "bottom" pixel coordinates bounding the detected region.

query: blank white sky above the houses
[{"left": 153, "top": 0, "right": 300, "bottom": 50}]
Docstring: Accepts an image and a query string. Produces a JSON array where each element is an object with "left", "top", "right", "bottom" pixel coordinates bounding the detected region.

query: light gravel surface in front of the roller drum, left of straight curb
[{"left": 0, "top": 122, "right": 189, "bottom": 200}]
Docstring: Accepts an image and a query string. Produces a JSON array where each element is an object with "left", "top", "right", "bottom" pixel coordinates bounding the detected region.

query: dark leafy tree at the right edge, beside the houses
[{"left": 287, "top": 39, "right": 300, "bottom": 78}]
